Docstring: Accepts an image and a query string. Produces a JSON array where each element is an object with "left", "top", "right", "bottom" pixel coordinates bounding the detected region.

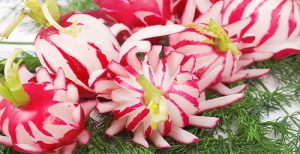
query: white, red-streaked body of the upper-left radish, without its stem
[{"left": 35, "top": 13, "right": 119, "bottom": 95}]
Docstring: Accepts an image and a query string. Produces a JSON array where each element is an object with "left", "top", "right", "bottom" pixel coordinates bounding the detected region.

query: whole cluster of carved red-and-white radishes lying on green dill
[{"left": 0, "top": 0, "right": 300, "bottom": 153}]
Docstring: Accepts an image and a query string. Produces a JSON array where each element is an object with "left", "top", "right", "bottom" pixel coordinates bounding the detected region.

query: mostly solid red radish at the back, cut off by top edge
[{"left": 94, "top": 0, "right": 171, "bottom": 31}]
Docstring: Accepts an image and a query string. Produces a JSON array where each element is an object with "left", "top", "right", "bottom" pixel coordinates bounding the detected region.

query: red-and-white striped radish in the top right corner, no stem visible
[{"left": 181, "top": 0, "right": 300, "bottom": 61}]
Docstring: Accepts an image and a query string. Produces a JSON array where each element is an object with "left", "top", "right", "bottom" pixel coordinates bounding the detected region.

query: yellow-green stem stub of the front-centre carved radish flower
[{"left": 136, "top": 75, "right": 168, "bottom": 130}]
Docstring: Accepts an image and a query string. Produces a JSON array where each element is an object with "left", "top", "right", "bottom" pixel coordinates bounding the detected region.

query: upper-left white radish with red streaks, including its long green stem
[{"left": 2, "top": 0, "right": 120, "bottom": 97}]
